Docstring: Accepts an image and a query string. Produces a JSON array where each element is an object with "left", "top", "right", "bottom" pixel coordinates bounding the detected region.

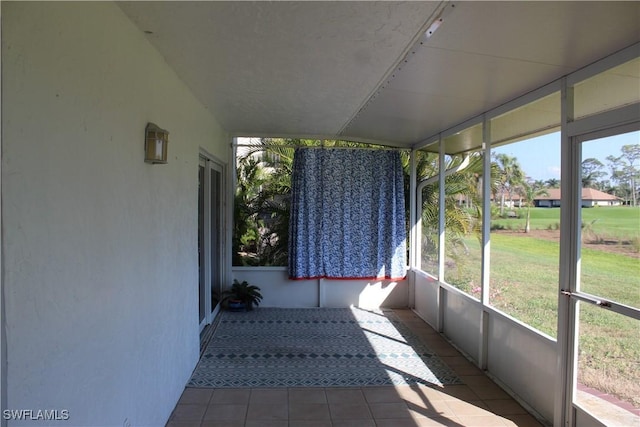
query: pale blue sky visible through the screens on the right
[{"left": 491, "top": 132, "right": 640, "bottom": 181}]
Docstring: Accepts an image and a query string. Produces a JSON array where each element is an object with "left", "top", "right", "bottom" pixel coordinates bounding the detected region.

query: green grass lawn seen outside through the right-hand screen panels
[{"left": 447, "top": 207, "right": 640, "bottom": 407}]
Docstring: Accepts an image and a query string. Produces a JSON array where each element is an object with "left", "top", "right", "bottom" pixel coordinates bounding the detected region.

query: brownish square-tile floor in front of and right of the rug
[{"left": 167, "top": 310, "right": 541, "bottom": 427}]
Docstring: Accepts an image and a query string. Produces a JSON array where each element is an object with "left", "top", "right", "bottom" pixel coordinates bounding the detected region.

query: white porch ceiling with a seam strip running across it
[{"left": 119, "top": 1, "right": 640, "bottom": 147}]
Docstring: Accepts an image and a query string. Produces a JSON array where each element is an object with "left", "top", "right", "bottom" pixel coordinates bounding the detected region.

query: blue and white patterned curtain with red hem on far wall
[{"left": 289, "top": 148, "right": 406, "bottom": 279}]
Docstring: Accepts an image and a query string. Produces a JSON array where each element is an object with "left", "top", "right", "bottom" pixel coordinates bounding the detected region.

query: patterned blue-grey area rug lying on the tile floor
[{"left": 188, "top": 308, "right": 460, "bottom": 388}]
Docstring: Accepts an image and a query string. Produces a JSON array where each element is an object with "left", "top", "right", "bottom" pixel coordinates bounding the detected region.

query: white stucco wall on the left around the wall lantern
[{"left": 1, "top": 2, "right": 230, "bottom": 427}]
